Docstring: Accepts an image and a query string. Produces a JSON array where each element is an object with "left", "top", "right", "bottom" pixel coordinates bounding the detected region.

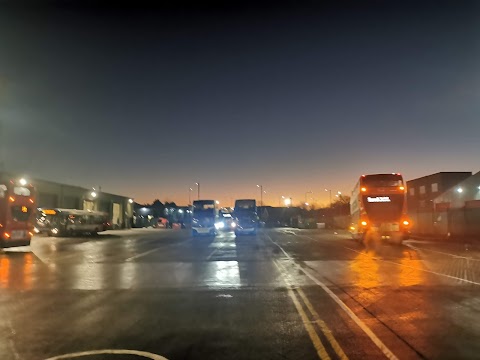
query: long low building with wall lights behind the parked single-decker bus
[{"left": 0, "top": 172, "right": 133, "bottom": 229}]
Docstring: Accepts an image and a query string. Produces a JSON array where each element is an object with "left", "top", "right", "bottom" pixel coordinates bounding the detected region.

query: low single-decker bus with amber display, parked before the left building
[{"left": 35, "top": 208, "right": 108, "bottom": 236}]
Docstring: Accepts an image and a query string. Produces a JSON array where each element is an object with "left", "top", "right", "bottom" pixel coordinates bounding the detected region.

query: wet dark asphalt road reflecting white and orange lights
[{"left": 0, "top": 229, "right": 480, "bottom": 360}]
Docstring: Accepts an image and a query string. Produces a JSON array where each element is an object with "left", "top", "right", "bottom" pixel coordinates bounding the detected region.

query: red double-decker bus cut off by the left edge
[{"left": 0, "top": 178, "right": 35, "bottom": 248}]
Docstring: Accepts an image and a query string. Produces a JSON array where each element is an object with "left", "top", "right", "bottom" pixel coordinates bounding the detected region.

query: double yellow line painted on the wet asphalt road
[{"left": 274, "top": 261, "right": 348, "bottom": 360}]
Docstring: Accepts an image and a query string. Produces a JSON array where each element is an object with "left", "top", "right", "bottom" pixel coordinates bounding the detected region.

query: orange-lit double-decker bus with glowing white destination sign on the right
[{"left": 350, "top": 173, "right": 410, "bottom": 244}]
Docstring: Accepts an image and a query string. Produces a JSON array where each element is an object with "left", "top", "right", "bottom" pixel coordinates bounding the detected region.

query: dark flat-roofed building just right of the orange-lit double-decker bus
[{"left": 407, "top": 172, "right": 472, "bottom": 236}]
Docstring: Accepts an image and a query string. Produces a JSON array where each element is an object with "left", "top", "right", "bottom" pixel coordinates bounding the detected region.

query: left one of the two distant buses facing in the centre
[{"left": 192, "top": 200, "right": 221, "bottom": 236}]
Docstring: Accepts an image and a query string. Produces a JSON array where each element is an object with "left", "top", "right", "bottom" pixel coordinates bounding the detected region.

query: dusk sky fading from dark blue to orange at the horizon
[{"left": 0, "top": 1, "right": 480, "bottom": 205}]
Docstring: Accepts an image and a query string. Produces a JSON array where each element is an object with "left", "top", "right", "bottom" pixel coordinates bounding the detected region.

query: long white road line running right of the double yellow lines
[{"left": 265, "top": 234, "right": 398, "bottom": 360}]
